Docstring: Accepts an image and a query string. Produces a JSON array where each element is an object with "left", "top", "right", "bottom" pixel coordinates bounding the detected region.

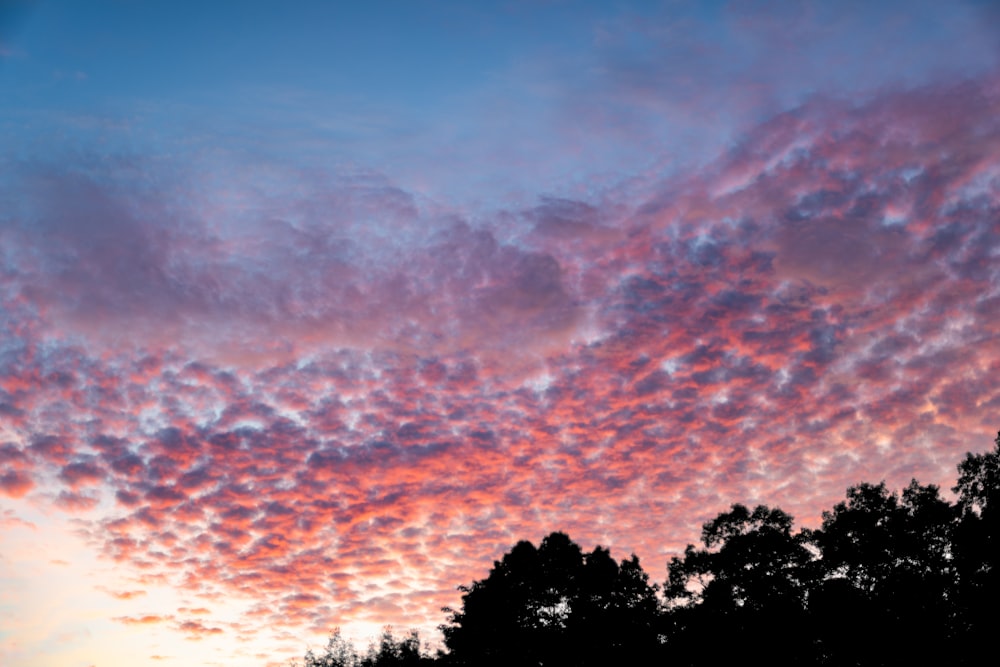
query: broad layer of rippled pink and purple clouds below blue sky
[{"left": 0, "top": 70, "right": 1000, "bottom": 664}]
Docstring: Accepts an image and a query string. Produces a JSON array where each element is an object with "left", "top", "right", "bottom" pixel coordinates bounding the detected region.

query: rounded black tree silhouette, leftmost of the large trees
[{"left": 441, "top": 533, "right": 657, "bottom": 667}]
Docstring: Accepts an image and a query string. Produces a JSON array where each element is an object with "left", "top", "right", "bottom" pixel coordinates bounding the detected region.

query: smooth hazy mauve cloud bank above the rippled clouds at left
[{"left": 7, "top": 166, "right": 579, "bottom": 366}]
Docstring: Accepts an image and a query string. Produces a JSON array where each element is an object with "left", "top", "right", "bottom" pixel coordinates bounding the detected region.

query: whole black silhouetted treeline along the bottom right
[{"left": 294, "top": 434, "right": 1000, "bottom": 667}]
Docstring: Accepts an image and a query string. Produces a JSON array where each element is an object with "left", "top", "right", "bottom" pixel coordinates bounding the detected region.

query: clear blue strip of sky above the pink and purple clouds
[{"left": 0, "top": 1, "right": 997, "bottom": 207}]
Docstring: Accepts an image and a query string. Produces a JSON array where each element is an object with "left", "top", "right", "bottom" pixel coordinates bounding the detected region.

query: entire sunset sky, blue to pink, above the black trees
[{"left": 0, "top": 0, "right": 1000, "bottom": 667}]
